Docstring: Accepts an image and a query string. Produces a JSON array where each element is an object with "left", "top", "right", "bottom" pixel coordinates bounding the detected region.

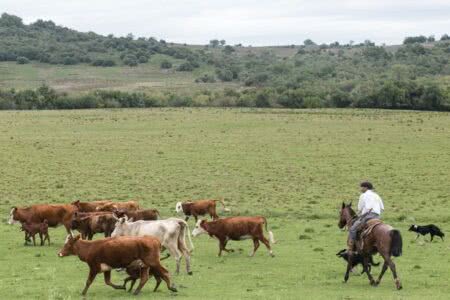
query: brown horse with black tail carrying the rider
[{"left": 338, "top": 203, "right": 402, "bottom": 290}]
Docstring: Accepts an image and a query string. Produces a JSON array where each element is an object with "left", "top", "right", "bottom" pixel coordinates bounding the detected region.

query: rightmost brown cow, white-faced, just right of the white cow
[{"left": 192, "top": 217, "right": 275, "bottom": 257}]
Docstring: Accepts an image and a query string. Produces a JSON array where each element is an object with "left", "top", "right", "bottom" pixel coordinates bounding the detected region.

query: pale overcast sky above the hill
[{"left": 0, "top": 0, "right": 450, "bottom": 46}]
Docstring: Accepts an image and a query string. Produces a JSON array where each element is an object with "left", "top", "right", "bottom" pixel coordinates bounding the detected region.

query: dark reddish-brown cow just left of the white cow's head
[{"left": 72, "top": 211, "right": 116, "bottom": 240}]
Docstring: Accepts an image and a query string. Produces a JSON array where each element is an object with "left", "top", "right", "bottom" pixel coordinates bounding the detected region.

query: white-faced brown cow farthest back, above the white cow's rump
[{"left": 175, "top": 199, "right": 230, "bottom": 222}]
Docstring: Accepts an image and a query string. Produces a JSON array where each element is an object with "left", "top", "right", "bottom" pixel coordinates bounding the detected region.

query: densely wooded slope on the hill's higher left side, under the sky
[{"left": 0, "top": 13, "right": 200, "bottom": 68}]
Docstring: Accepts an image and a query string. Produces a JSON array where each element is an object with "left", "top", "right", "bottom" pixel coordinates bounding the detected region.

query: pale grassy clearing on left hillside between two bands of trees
[{"left": 0, "top": 55, "right": 237, "bottom": 95}]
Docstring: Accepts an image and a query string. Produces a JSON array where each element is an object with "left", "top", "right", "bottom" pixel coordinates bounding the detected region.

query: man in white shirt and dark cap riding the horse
[{"left": 348, "top": 181, "right": 384, "bottom": 251}]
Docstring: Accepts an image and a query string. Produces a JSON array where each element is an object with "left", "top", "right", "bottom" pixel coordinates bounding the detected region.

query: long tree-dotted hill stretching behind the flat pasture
[{"left": 0, "top": 13, "right": 450, "bottom": 110}]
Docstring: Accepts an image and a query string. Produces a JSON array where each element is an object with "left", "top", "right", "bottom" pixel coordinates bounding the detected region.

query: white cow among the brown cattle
[{"left": 111, "top": 217, "right": 194, "bottom": 275}]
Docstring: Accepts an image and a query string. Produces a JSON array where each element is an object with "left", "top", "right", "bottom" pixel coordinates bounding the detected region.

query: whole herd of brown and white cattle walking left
[{"left": 8, "top": 200, "right": 275, "bottom": 295}]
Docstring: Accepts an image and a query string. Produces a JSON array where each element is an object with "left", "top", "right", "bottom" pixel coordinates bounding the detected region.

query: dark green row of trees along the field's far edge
[{"left": 0, "top": 80, "right": 450, "bottom": 111}]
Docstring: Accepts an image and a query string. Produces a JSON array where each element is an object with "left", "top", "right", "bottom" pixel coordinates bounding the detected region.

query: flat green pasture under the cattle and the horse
[{"left": 0, "top": 108, "right": 450, "bottom": 299}]
